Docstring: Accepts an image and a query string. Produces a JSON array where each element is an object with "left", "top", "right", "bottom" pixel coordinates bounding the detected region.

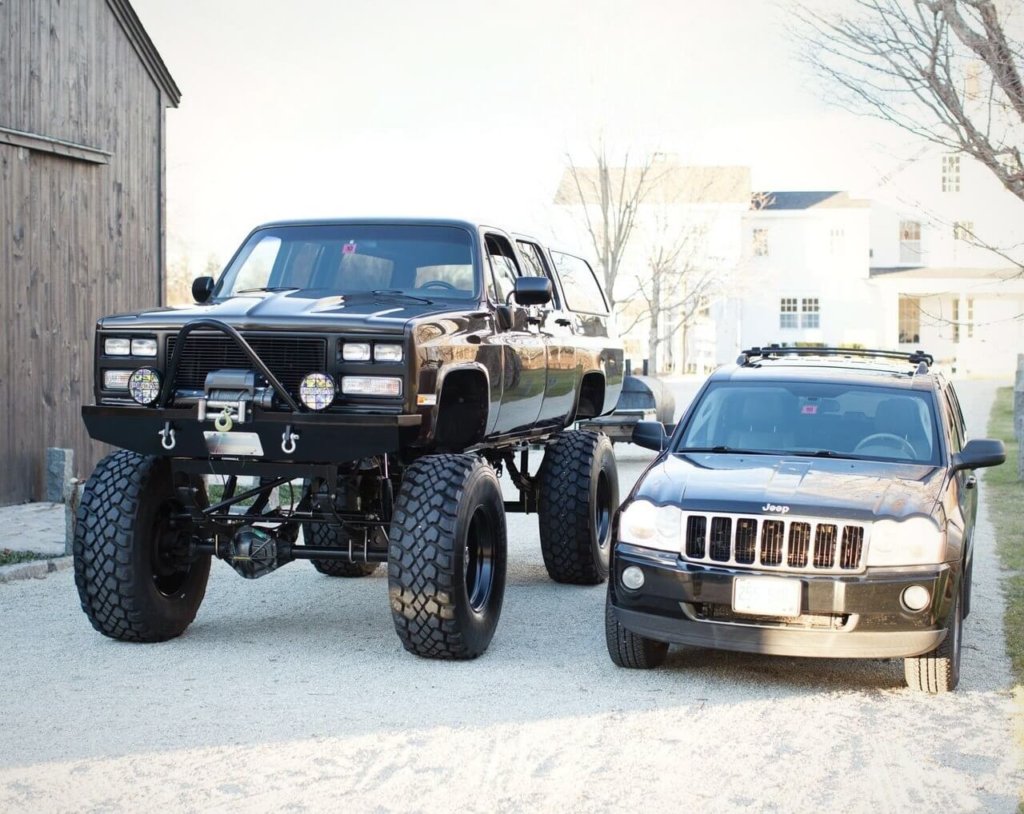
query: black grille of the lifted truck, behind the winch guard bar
[{"left": 167, "top": 334, "right": 327, "bottom": 394}]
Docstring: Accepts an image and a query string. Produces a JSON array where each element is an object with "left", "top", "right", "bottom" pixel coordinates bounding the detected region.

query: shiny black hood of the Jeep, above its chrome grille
[{"left": 634, "top": 453, "right": 945, "bottom": 521}]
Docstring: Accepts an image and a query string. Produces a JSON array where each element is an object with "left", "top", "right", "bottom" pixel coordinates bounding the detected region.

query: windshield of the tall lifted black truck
[{"left": 214, "top": 223, "right": 478, "bottom": 301}]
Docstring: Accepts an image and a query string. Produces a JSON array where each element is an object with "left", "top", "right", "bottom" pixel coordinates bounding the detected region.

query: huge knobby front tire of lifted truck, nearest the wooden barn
[{"left": 74, "top": 449, "right": 210, "bottom": 642}]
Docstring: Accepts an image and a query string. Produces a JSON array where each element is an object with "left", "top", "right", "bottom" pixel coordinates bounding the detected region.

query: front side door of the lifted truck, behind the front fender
[{"left": 482, "top": 230, "right": 547, "bottom": 435}]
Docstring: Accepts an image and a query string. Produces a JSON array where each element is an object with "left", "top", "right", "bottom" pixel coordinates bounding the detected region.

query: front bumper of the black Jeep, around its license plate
[{"left": 611, "top": 543, "right": 958, "bottom": 658}]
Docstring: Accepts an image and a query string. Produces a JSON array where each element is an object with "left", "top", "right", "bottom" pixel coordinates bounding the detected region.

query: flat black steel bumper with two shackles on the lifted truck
[{"left": 82, "top": 405, "right": 423, "bottom": 464}]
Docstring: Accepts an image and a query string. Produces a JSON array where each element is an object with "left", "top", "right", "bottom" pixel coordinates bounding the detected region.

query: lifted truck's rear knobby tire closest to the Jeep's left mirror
[{"left": 540, "top": 430, "right": 618, "bottom": 585}]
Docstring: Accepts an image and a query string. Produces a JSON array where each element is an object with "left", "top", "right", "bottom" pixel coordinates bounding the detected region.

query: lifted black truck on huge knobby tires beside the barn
[{"left": 74, "top": 219, "right": 623, "bottom": 658}]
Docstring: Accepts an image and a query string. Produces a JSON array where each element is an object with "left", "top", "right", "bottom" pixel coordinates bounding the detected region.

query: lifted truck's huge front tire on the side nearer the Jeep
[{"left": 388, "top": 455, "right": 507, "bottom": 659}]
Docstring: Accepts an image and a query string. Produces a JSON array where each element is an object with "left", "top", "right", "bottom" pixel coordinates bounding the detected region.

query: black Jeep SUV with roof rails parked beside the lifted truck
[{"left": 605, "top": 346, "right": 1006, "bottom": 692}]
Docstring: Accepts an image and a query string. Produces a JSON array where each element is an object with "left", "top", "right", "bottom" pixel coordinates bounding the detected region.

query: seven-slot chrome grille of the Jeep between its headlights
[{"left": 683, "top": 514, "right": 864, "bottom": 573}]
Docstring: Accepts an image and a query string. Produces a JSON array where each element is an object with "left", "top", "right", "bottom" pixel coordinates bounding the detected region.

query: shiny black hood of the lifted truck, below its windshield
[{"left": 99, "top": 291, "right": 475, "bottom": 333}]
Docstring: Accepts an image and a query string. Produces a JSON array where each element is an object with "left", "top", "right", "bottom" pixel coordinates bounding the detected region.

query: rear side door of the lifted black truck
[{"left": 516, "top": 239, "right": 580, "bottom": 425}]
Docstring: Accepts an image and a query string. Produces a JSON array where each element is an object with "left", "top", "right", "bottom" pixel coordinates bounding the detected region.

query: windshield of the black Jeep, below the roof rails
[{"left": 673, "top": 381, "right": 940, "bottom": 465}]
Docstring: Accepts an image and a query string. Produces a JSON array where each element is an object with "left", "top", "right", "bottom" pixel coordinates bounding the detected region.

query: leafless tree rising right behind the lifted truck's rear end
[{"left": 555, "top": 141, "right": 654, "bottom": 311}]
